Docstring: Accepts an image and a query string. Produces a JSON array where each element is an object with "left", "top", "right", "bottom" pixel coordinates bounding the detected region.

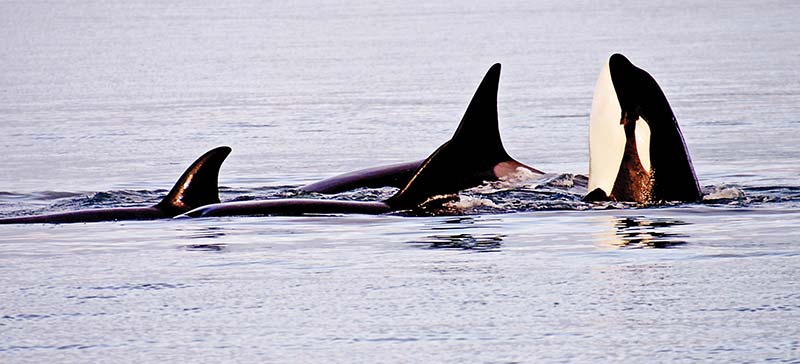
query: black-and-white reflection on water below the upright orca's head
[{"left": 600, "top": 216, "right": 688, "bottom": 249}]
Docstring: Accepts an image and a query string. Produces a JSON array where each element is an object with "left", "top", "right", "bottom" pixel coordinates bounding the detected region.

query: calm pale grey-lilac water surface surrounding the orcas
[{"left": 0, "top": 1, "right": 800, "bottom": 363}]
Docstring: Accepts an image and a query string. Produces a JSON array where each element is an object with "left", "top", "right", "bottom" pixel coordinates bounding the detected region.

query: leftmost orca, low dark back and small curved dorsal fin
[{"left": 0, "top": 147, "right": 231, "bottom": 224}]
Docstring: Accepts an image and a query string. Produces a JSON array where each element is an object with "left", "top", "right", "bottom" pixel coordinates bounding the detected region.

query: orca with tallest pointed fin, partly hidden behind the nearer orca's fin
[{"left": 301, "top": 64, "right": 544, "bottom": 193}]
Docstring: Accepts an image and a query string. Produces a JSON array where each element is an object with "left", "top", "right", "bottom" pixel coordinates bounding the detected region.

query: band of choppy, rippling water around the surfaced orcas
[{"left": 0, "top": 174, "right": 800, "bottom": 216}]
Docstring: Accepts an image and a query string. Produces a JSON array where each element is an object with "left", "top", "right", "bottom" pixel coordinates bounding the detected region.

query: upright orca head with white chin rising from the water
[{"left": 585, "top": 54, "right": 701, "bottom": 204}]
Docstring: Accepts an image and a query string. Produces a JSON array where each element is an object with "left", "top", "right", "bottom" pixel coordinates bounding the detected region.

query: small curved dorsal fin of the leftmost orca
[{"left": 155, "top": 147, "right": 231, "bottom": 216}]
